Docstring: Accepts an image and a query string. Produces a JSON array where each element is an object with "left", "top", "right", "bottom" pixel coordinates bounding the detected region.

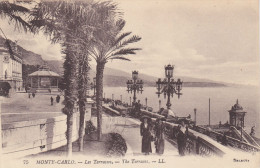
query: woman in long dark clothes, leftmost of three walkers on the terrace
[{"left": 140, "top": 116, "right": 153, "bottom": 155}]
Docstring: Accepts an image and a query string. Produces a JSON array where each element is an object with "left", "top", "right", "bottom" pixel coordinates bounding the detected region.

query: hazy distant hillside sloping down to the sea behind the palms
[{"left": 0, "top": 36, "right": 230, "bottom": 87}]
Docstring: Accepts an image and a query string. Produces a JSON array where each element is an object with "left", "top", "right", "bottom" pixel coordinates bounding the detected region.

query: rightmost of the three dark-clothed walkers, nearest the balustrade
[{"left": 177, "top": 121, "right": 188, "bottom": 156}]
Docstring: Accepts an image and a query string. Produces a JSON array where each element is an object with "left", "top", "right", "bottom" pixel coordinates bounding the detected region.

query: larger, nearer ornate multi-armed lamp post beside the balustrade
[{"left": 156, "top": 64, "right": 182, "bottom": 110}]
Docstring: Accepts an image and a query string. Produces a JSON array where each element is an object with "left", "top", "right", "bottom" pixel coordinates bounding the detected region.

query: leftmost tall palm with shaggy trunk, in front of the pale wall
[{"left": 31, "top": 1, "right": 91, "bottom": 156}]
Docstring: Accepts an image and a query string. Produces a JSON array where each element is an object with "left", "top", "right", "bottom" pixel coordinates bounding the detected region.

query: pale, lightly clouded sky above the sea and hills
[{"left": 0, "top": 0, "right": 260, "bottom": 85}]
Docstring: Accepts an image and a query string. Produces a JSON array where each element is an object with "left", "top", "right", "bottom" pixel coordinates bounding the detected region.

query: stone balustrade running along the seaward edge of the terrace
[{"left": 103, "top": 105, "right": 259, "bottom": 156}]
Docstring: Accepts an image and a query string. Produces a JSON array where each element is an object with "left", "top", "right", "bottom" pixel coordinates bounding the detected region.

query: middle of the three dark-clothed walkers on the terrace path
[{"left": 154, "top": 118, "right": 166, "bottom": 155}]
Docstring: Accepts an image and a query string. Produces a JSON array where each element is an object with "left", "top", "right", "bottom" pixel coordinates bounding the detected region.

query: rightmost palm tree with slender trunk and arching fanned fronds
[{"left": 89, "top": 17, "right": 141, "bottom": 140}]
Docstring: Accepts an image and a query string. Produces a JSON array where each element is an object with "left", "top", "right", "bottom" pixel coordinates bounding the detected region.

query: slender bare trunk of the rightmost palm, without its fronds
[{"left": 96, "top": 62, "right": 105, "bottom": 140}]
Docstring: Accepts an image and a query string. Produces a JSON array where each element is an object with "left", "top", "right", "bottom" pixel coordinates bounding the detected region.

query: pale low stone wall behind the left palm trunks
[{"left": 2, "top": 113, "right": 79, "bottom": 157}]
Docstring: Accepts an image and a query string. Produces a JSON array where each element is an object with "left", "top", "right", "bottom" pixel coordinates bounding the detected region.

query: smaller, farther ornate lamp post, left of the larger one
[{"left": 126, "top": 71, "right": 144, "bottom": 103}]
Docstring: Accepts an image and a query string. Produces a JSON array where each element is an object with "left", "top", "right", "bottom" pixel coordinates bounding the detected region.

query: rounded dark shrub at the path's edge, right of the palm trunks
[{"left": 107, "top": 133, "right": 127, "bottom": 157}]
